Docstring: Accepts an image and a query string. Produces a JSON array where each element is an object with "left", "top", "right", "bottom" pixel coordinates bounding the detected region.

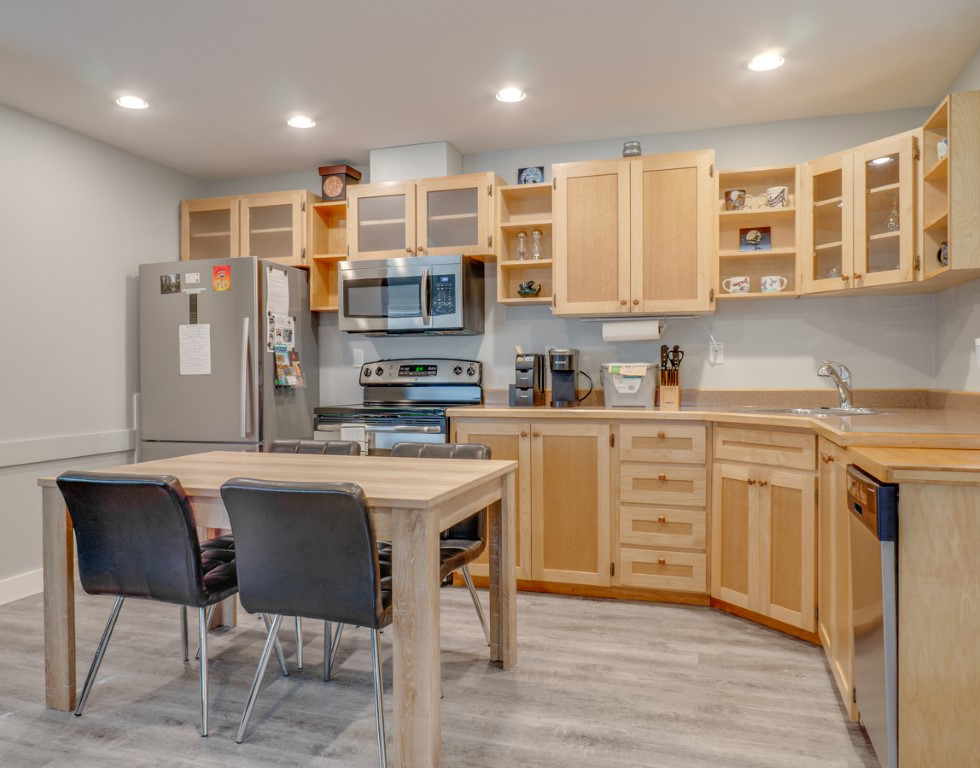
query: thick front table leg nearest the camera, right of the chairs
[{"left": 391, "top": 509, "right": 442, "bottom": 768}]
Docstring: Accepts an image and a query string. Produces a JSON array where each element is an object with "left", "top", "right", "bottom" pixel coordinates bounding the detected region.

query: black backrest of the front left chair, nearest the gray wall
[{"left": 58, "top": 472, "right": 207, "bottom": 606}]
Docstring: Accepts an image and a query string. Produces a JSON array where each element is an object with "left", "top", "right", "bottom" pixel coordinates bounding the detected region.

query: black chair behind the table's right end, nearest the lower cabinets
[{"left": 378, "top": 443, "right": 490, "bottom": 645}]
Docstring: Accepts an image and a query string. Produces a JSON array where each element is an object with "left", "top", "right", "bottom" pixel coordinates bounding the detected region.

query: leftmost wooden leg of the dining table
[{"left": 41, "top": 486, "right": 75, "bottom": 711}]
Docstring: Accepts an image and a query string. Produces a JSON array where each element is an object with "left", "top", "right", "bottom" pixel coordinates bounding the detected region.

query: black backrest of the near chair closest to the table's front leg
[{"left": 221, "top": 478, "right": 383, "bottom": 629}]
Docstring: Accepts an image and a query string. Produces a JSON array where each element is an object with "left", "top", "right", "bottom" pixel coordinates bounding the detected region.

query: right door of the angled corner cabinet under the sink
[{"left": 759, "top": 470, "right": 817, "bottom": 632}]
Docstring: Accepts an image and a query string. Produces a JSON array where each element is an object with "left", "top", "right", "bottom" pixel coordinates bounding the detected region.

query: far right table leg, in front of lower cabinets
[{"left": 488, "top": 472, "right": 517, "bottom": 669}]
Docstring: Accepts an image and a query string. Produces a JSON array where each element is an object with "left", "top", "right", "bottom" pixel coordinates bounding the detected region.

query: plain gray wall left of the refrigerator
[{"left": 0, "top": 106, "right": 203, "bottom": 603}]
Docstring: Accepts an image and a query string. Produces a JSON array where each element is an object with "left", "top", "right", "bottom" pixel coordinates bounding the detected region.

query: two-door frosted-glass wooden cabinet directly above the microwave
[{"left": 347, "top": 173, "right": 499, "bottom": 259}]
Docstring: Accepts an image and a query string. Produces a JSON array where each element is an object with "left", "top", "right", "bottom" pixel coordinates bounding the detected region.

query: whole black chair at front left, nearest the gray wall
[{"left": 58, "top": 472, "right": 238, "bottom": 736}]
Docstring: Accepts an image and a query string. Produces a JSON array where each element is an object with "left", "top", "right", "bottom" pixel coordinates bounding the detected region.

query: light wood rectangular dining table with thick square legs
[{"left": 38, "top": 451, "right": 517, "bottom": 768}]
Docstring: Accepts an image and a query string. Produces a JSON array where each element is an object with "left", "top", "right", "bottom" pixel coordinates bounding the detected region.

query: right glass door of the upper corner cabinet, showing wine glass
[{"left": 853, "top": 135, "right": 916, "bottom": 287}]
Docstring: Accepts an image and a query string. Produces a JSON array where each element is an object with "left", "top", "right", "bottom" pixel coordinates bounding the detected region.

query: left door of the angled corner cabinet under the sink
[{"left": 711, "top": 463, "right": 761, "bottom": 610}]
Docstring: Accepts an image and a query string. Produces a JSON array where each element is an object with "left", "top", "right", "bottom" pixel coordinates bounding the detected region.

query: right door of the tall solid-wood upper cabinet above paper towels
[{"left": 630, "top": 151, "right": 717, "bottom": 312}]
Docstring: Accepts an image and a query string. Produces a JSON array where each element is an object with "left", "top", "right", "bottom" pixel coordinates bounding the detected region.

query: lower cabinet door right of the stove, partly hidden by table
[{"left": 454, "top": 419, "right": 531, "bottom": 579}]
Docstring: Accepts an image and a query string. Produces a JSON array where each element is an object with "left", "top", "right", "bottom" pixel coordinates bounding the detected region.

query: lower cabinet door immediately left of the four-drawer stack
[{"left": 531, "top": 420, "right": 612, "bottom": 586}]
